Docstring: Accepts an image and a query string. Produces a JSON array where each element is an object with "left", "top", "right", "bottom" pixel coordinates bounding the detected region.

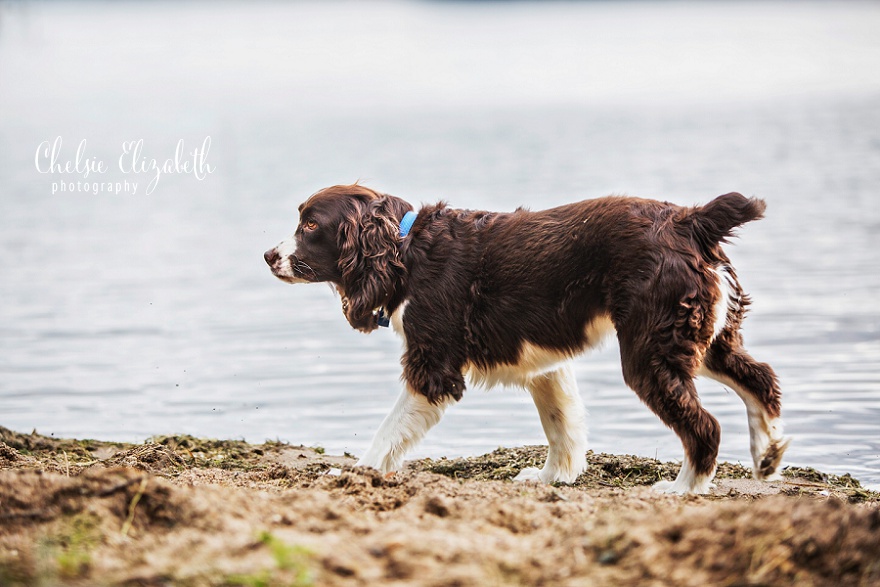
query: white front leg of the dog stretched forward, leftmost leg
[{"left": 357, "top": 386, "right": 455, "bottom": 473}]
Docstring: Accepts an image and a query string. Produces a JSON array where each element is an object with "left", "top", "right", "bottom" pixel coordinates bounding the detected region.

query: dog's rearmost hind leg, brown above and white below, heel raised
[{"left": 700, "top": 330, "right": 791, "bottom": 481}]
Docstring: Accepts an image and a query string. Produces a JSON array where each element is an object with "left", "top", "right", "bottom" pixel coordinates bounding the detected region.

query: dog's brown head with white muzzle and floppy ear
[{"left": 264, "top": 184, "right": 412, "bottom": 332}]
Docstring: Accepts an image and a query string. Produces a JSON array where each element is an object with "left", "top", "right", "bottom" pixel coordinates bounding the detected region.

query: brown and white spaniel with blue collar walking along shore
[{"left": 265, "top": 185, "right": 788, "bottom": 493}]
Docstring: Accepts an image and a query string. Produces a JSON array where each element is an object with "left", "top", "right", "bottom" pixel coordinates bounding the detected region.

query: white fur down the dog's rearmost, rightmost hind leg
[{"left": 700, "top": 367, "right": 791, "bottom": 481}]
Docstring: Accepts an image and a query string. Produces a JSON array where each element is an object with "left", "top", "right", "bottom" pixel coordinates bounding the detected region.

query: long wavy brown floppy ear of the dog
[{"left": 337, "top": 196, "right": 409, "bottom": 332}]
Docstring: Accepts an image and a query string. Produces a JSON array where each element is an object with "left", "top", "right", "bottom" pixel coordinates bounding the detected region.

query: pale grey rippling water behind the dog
[{"left": 0, "top": 2, "right": 880, "bottom": 484}]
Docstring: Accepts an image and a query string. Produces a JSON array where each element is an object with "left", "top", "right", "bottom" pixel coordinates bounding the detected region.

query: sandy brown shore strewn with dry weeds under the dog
[{"left": 0, "top": 428, "right": 880, "bottom": 587}]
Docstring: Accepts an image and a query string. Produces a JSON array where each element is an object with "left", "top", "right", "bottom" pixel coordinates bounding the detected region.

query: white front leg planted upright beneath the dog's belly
[{"left": 515, "top": 363, "right": 587, "bottom": 483}]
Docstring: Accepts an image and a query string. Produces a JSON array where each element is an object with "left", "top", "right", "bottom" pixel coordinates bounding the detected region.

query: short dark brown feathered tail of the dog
[{"left": 679, "top": 192, "right": 767, "bottom": 251}]
